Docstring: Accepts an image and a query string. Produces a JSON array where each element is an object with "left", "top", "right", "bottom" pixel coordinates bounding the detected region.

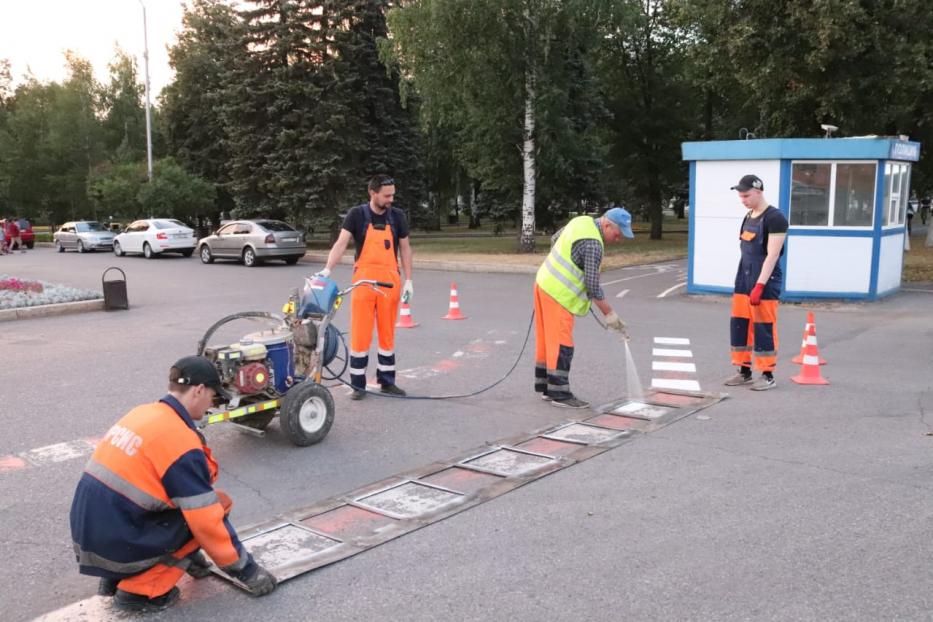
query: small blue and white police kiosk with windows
[{"left": 682, "top": 137, "right": 920, "bottom": 300}]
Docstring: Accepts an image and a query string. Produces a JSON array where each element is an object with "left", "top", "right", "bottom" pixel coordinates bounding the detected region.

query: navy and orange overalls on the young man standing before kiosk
[{"left": 729, "top": 206, "right": 783, "bottom": 372}]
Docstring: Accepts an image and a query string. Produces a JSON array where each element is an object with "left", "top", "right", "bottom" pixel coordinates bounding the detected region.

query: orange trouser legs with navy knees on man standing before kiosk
[{"left": 729, "top": 294, "right": 778, "bottom": 372}]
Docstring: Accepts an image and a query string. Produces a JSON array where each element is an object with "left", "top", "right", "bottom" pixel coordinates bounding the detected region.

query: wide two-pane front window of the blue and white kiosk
[{"left": 790, "top": 162, "right": 876, "bottom": 227}]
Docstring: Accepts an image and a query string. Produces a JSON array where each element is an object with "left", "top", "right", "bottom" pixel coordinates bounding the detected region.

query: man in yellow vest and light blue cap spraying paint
[{"left": 534, "top": 207, "right": 635, "bottom": 408}]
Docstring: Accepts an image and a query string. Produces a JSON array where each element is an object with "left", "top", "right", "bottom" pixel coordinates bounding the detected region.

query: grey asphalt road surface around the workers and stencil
[{"left": 0, "top": 249, "right": 933, "bottom": 621}]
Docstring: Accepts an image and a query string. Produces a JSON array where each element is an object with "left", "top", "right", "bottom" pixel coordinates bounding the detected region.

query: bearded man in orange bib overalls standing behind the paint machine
[{"left": 318, "top": 175, "right": 414, "bottom": 400}]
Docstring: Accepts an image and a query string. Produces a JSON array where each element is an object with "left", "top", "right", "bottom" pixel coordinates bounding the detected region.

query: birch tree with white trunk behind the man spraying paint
[{"left": 389, "top": 0, "right": 603, "bottom": 252}]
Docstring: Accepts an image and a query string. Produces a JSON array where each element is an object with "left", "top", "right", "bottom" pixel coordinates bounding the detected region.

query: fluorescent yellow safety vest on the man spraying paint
[{"left": 535, "top": 216, "right": 603, "bottom": 315}]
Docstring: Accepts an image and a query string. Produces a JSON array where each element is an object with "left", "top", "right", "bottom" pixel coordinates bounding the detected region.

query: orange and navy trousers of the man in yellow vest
[{"left": 534, "top": 283, "right": 574, "bottom": 400}]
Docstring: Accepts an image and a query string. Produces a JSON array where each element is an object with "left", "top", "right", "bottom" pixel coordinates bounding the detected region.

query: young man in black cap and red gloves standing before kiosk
[{"left": 725, "top": 175, "right": 787, "bottom": 391}]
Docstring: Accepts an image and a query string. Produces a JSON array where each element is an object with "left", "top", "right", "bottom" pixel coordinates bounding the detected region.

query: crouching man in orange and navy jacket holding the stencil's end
[{"left": 71, "top": 356, "right": 276, "bottom": 612}]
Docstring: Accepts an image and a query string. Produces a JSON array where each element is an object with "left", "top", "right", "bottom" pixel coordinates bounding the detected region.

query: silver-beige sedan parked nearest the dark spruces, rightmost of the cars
[{"left": 198, "top": 220, "right": 307, "bottom": 267}]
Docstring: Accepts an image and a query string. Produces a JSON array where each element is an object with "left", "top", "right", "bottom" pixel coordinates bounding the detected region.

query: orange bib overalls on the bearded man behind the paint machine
[{"left": 350, "top": 204, "right": 401, "bottom": 390}]
